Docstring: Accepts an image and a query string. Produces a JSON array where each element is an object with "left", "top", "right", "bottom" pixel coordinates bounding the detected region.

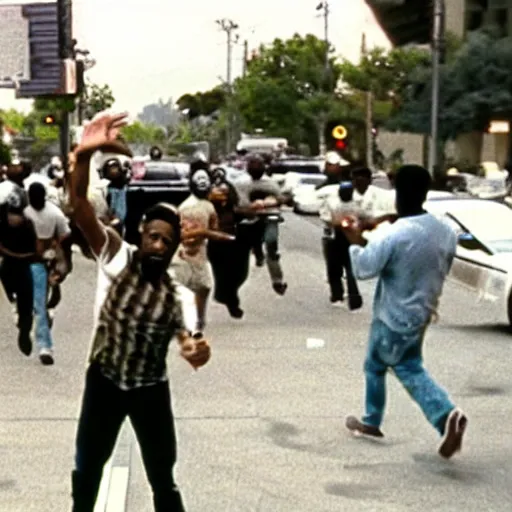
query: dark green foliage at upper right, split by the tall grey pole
[{"left": 390, "top": 31, "right": 512, "bottom": 141}]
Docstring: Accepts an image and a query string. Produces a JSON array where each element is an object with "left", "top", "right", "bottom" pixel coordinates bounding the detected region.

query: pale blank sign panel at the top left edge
[{"left": 0, "top": 5, "right": 30, "bottom": 89}]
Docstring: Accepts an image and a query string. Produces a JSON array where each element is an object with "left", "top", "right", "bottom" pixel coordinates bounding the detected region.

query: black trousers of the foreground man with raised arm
[{"left": 72, "top": 364, "right": 185, "bottom": 512}]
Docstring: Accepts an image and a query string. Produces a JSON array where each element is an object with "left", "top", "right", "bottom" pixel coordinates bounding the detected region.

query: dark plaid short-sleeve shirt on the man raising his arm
[{"left": 89, "top": 234, "right": 185, "bottom": 389}]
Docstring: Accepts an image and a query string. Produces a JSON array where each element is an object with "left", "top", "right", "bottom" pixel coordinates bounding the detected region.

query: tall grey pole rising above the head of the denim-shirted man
[{"left": 428, "top": 0, "right": 445, "bottom": 177}]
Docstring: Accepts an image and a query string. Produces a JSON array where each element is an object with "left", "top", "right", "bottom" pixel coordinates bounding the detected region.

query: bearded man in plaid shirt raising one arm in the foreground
[{"left": 70, "top": 113, "right": 210, "bottom": 512}]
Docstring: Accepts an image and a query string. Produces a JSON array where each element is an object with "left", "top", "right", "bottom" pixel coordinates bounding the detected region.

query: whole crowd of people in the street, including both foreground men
[{"left": 0, "top": 113, "right": 467, "bottom": 512}]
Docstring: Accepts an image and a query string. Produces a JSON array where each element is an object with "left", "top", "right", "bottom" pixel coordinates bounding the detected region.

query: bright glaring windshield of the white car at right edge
[{"left": 450, "top": 202, "right": 512, "bottom": 253}]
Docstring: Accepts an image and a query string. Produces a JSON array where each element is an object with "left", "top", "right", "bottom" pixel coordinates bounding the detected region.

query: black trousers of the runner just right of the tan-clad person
[{"left": 208, "top": 239, "right": 250, "bottom": 307}]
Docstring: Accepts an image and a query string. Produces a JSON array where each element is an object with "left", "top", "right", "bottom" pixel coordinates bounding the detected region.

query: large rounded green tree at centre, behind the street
[{"left": 234, "top": 34, "right": 340, "bottom": 153}]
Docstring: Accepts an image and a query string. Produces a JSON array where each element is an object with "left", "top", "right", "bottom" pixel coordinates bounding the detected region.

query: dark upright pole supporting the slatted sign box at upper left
[{"left": 57, "top": 0, "right": 75, "bottom": 171}]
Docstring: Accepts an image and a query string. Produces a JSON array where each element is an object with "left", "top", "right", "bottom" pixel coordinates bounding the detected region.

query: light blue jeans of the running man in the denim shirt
[{"left": 363, "top": 319, "right": 454, "bottom": 435}]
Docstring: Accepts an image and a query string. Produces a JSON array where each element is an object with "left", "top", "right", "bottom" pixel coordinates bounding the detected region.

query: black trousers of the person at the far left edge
[{"left": 0, "top": 257, "right": 34, "bottom": 334}]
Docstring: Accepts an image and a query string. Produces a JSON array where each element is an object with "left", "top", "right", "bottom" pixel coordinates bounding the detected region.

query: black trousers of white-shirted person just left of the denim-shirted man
[{"left": 322, "top": 234, "right": 361, "bottom": 308}]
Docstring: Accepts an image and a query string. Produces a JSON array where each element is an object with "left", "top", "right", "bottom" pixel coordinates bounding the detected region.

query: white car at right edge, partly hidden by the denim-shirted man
[{"left": 425, "top": 198, "right": 512, "bottom": 324}]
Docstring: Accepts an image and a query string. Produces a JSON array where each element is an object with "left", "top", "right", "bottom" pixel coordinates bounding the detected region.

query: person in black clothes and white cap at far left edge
[{"left": 0, "top": 180, "right": 38, "bottom": 356}]
